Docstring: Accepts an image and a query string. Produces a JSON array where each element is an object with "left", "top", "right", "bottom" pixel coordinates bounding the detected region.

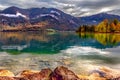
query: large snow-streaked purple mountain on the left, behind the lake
[{"left": 0, "top": 6, "right": 79, "bottom": 30}]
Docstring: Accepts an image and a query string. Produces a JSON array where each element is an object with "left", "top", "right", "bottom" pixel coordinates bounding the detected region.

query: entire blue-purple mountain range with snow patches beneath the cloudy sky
[{"left": 0, "top": 6, "right": 120, "bottom": 31}]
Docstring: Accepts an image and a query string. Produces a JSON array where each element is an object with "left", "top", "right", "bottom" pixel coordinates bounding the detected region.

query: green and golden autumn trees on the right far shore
[{"left": 76, "top": 19, "right": 120, "bottom": 33}]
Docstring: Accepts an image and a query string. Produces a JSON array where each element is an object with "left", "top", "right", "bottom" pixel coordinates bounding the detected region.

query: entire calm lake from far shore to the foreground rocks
[{"left": 0, "top": 32, "right": 120, "bottom": 74}]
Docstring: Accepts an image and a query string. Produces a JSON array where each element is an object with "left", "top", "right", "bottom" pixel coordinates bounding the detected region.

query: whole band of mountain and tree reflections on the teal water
[{"left": 0, "top": 32, "right": 120, "bottom": 54}]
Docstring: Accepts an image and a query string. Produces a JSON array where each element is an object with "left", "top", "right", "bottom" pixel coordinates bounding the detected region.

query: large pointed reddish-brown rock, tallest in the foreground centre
[{"left": 51, "top": 66, "right": 79, "bottom": 80}]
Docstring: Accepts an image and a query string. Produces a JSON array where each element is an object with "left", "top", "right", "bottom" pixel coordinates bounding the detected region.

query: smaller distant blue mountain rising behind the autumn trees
[{"left": 79, "top": 13, "right": 120, "bottom": 25}]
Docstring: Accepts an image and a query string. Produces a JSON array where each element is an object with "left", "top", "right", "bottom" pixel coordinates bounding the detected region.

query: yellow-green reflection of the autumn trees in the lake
[{"left": 79, "top": 33, "right": 120, "bottom": 48}]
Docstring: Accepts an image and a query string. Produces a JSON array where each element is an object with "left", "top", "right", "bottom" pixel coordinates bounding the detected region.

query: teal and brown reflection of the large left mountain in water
[{"left": 0, "top": 32, "right": 78, "bottom": 54}]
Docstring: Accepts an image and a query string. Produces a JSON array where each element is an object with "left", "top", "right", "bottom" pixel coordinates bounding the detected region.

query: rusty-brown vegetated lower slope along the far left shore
[{"left": 0, "top": 21, "right": 50, "bottom": 32}]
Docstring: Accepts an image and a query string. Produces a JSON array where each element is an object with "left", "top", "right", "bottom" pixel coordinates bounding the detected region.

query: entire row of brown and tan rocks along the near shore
[{"left": 0, "top": 66, "right": 120, "bottom": 80}]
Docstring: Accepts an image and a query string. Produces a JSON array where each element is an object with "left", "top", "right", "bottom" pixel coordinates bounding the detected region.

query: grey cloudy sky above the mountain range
[{"left": 0, "top": 0, "right": 120, "bottom": 16}]
